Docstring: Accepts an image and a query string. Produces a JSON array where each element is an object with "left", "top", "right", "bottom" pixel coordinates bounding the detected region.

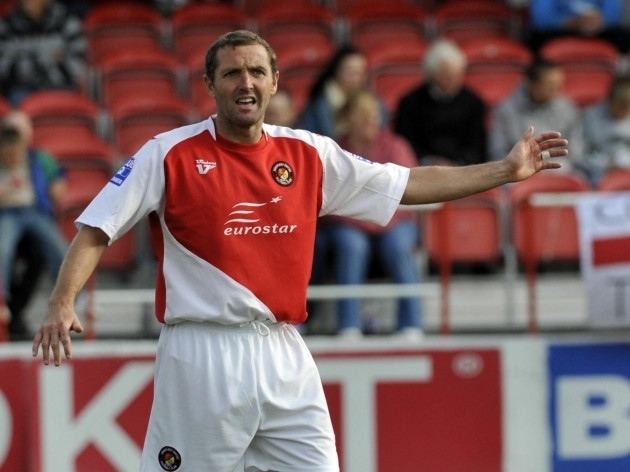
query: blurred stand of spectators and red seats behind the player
[{"left": 0, "top": 0, "right": 630, "bottom": 338}]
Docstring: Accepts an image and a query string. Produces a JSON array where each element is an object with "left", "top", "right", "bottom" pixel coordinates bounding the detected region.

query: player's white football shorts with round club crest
[{"left": 140, "top": 321, "right": 339, "bottom": 472}]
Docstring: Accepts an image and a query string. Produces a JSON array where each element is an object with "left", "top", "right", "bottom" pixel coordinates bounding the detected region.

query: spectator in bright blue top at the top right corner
[{"left": 529, "top": 0, "right": 630, "bottom": 52}]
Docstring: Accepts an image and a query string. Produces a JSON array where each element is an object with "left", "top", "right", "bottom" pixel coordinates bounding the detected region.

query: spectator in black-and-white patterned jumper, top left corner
[{"left": 0, "top": 0, "right": 87, "bottom": 105}]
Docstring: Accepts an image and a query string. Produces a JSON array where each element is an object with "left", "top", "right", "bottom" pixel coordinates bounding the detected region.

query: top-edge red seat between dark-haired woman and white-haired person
[{"left": 346, "top": 0, "right": 426, "bottom": 51}]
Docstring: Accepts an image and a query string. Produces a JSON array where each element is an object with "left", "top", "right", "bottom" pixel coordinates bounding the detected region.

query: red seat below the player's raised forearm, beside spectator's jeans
[{"left": 424, "top": 189, "right": 502, "bottom": 264}]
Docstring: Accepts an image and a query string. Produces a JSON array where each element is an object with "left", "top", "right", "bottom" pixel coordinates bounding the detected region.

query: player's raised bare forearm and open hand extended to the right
[{"left": 401, "top": 127, "right": 568, "bottom": 205}]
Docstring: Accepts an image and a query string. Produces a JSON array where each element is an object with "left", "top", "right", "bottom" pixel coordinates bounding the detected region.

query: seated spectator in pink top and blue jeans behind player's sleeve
[{"left": 314, "top": 91, "right": 422, "bottom": 337}]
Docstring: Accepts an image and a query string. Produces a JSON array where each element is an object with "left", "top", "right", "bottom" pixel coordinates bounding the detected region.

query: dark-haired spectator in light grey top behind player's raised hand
[{"left": 490, "top": 59, "right": 584, "bottom": 171}]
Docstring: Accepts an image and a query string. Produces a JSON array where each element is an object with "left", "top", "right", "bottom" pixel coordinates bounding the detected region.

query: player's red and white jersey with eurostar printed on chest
[{"left": 77, "top": 118, "right": 409, "bottom": 324}]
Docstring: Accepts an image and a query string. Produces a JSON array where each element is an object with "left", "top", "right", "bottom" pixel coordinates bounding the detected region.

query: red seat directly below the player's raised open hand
[{"left": 510, "top": 172, "right": 589, "bottom": 265}]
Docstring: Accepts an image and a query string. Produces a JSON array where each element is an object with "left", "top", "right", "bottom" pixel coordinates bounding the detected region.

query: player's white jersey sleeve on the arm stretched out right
[{"left": 318, "top": 137, "right": 409, "bottom": 226}]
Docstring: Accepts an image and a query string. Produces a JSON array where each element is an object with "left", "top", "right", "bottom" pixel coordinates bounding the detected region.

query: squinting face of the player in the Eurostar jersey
[{"left": 206, "top": 44, "right": 278, "bottom": 128}]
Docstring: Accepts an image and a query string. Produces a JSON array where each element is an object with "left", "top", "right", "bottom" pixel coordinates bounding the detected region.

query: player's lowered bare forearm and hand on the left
[{"left": 33, "top": 226, "right": 109, "bottom": 366}]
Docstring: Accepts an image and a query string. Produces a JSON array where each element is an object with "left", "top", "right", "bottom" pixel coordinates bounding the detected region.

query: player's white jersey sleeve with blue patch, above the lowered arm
[{"left": 76, "top": 139, "right": 165, "bottom": 244}]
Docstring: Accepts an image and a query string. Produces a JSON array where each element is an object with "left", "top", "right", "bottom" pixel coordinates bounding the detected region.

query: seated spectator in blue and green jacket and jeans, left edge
[{"left": 0, "top": 124, "right": 66, "bottom": 336}]
